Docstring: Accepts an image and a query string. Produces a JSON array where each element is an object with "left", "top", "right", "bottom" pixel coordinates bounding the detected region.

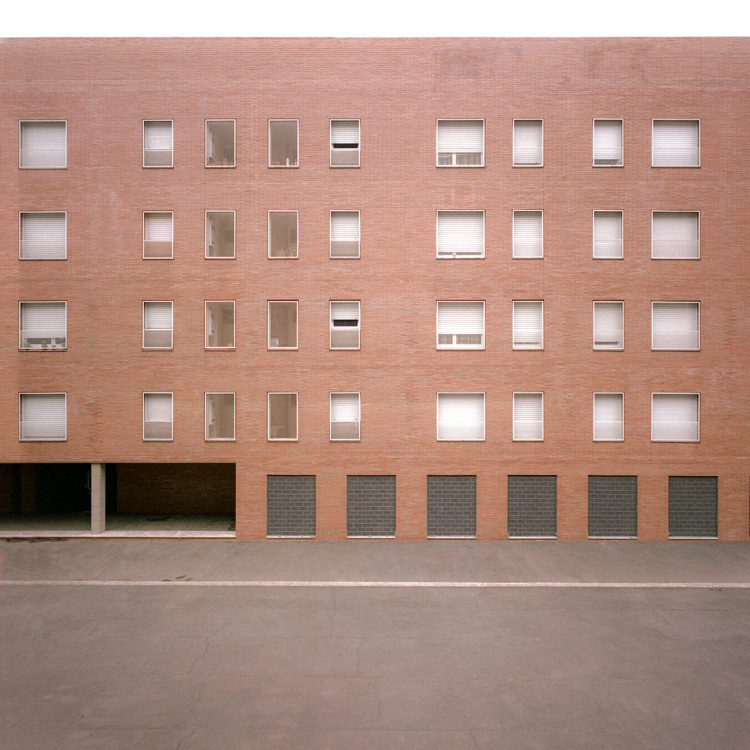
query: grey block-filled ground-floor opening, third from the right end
[{"left": 508, "top": 476, "right": 557, "bottom": 536}]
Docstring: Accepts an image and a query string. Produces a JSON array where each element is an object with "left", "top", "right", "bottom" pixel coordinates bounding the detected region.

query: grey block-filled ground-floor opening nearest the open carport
[{"left": 266, "top": 475, "right": 315, "bottom": 536}]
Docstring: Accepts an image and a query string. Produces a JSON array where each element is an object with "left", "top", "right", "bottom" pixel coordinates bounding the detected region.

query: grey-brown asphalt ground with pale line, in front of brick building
[{"left": 0, "top": 539, "right": 750, "bottom": 750}]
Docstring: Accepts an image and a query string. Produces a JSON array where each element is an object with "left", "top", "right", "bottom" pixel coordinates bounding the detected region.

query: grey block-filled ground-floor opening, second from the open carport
[{"left": 346, "top": 476, "right": 396, "bottom": 536}]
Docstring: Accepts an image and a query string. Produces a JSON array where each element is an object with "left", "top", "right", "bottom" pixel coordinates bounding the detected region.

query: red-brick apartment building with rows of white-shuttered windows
[{"left": 0, "top": 38, "right": 750, "bottom": 540}]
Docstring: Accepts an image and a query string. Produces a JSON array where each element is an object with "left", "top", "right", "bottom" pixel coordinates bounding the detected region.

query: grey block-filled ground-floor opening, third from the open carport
[{"left": 427, "top": 476, "right": 477, "bottom": 536}]
